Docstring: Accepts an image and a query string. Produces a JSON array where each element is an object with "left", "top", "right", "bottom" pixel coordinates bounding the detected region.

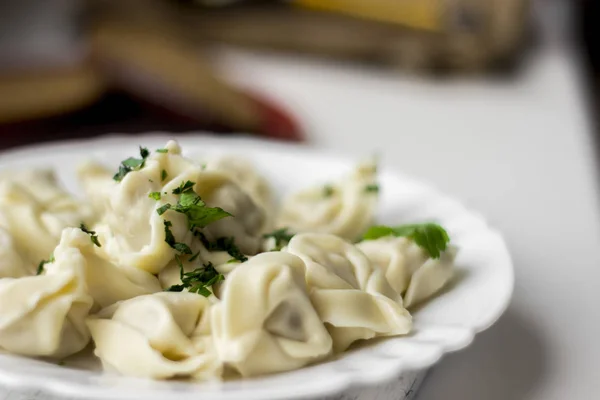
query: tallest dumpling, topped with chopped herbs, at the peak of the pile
[{"left": 85, "top": 142, "right": 200, "bottom": 273}]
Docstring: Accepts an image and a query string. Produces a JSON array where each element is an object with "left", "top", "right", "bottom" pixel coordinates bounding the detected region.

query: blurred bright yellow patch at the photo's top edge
[{"left": 292, "top": 0, "right": 444, "bottom": 31}]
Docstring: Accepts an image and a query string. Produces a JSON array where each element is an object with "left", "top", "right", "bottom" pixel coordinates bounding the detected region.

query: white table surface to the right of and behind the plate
[{"left": 219, "top": 42, "right": 600, "bottom": 400}]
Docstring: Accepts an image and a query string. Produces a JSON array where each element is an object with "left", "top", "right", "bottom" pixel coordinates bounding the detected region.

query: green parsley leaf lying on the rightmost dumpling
[{"left": 363, "top": 223, "right": 450, "bottom": 258}]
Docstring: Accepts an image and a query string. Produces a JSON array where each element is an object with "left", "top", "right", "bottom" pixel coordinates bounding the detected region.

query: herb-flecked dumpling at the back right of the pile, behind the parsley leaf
[{"left": 276, "top": 159, "right": 378, "bottom": 241}]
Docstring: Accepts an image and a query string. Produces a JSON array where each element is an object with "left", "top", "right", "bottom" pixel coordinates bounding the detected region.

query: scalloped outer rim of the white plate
[{"left": 0, "top": 132, "right": 514, "bottom": 400}]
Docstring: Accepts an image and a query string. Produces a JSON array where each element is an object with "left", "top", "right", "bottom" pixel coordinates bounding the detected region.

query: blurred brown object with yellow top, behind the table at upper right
[{"left": 179, "top": 0, "right": 529, "bottom": 73}]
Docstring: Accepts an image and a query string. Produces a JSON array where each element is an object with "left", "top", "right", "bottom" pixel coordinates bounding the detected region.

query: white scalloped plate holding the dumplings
[{"left": 0, "top": 135, "right": 514, "bottom": 400}]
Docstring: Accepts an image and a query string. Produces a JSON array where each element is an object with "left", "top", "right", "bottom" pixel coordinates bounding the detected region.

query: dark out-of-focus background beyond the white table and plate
[{"left": 0, "top": 0, "right": 600, "bottom": 148}]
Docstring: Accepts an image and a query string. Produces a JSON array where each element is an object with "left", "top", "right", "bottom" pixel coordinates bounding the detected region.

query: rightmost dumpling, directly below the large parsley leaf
[{"left": 357, "top": 236, "right": 457, "bottom": 308}]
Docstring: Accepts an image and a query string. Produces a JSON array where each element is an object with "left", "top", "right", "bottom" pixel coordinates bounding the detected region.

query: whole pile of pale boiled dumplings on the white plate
[{"left": 0, "top": 141, "right": 456, "bottom": 380}]
